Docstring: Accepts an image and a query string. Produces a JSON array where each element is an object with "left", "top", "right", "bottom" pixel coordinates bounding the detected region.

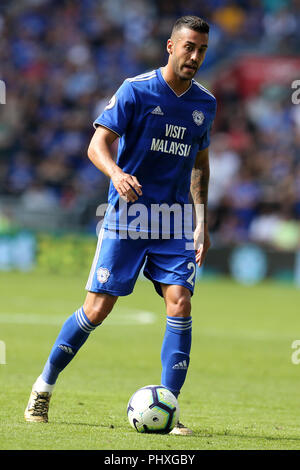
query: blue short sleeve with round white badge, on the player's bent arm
[{"left": 93, "top": 80, "right": 134, "bottom": 137}]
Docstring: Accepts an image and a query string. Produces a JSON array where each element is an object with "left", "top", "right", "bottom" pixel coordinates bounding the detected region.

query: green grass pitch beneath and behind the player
[{"left": 0, "top": 273, "right": 300, "bottom": 451}]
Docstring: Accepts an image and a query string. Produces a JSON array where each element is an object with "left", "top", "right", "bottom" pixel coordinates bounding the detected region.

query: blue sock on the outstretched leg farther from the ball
[{"left": 41, "top": 307, "right": 98, "bottom": 385}]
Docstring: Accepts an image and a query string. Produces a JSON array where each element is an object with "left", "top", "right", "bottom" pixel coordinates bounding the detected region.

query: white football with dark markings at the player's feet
[{"left": 127, "top": 385, "right": 179, "bottom": 434}]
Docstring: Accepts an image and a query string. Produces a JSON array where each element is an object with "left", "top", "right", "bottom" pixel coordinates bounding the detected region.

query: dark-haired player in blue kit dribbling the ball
[{"left": 25, "top": 16, "right": 216, "bottom": 435}]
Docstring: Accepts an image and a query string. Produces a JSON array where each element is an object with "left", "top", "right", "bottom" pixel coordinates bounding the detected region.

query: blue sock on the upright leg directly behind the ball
[{"left": 161, "top": 316, "right": 192, "bottom": 397}]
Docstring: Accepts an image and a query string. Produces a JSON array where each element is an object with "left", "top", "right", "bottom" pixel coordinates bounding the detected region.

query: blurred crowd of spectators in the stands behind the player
[{"left": 0, "top": 0, "right": 300, "bottom": 250}]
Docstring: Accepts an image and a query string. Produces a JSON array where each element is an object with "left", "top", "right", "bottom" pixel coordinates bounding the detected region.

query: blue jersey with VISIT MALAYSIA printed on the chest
[{"left": 94, "top": 69, "right": 216, "bottom": 230}]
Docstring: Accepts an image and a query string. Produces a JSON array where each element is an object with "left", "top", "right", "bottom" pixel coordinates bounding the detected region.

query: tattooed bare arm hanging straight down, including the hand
[{"left": 190, "top": 147, "right": 210, "bottom": 267}]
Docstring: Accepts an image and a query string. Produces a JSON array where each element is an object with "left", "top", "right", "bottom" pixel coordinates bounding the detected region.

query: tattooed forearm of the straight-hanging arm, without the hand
[{"left": 190, "top": 149, "right": 210, "bottom": 223}]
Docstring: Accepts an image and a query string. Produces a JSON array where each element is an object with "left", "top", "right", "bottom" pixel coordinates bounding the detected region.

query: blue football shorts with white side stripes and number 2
[{"left": 86, "top": 228, "right": 196, "bottom": 296}]
